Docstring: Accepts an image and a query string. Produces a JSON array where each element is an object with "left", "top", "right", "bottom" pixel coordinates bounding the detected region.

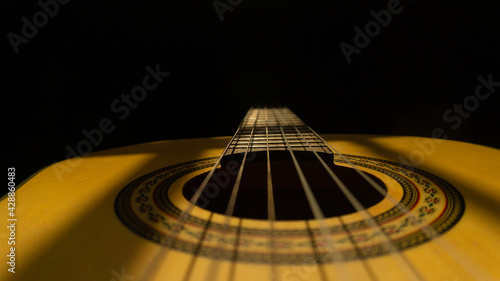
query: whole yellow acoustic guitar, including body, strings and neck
[{"left": 0, "top": 108, "right": 500, "bottom": 281}]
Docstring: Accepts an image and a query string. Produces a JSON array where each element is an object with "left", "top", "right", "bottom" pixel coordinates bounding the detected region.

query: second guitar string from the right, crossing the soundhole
[{"left": 278, "top": 107, "right": 423, "bottom": 280}]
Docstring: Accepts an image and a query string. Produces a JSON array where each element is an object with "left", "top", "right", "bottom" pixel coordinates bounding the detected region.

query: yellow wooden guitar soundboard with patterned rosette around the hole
[{"left": 0, "top": 134, "right": 500, "bottom": 281}]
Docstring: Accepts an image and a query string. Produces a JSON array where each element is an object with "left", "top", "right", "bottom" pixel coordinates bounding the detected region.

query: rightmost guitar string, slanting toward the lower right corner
[{"left": 308, "top": 116, "right": 495, "bottom": 280}]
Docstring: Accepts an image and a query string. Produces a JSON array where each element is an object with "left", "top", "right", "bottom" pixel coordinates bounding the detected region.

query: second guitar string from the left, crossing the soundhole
[{"left": 205, "top": 106, "right": 259, "bottom": 281}]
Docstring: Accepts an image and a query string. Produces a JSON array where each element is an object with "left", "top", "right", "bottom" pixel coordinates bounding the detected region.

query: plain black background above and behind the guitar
[{"left": 2, "top": 0, "right": 500, "bottom": 192}]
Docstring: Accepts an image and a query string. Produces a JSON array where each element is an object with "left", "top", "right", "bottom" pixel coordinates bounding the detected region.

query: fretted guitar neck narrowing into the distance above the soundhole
[{"left": 225, "top": 108, "right": 331, "bottom": 155}]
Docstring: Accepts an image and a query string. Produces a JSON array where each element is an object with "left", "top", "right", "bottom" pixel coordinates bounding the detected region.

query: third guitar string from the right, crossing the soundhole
[{"left": 273, "top": 107, "right": 352, "bottom": 280}]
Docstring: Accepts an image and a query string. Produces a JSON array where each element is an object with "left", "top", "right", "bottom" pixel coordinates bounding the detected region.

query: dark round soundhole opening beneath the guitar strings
[{"left": 183, "top": 151, "right": 387, "bottom": 220}]
